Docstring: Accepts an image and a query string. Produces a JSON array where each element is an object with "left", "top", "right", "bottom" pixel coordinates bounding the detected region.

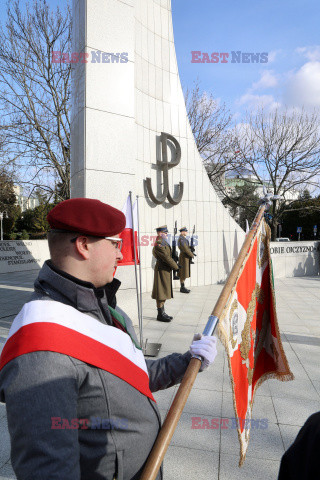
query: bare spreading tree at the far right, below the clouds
[{"left": 231, "top": 109, "right": 320, "bottom": 239}]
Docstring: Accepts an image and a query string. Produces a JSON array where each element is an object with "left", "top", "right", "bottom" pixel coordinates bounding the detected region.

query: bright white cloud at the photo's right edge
[{"left": 283, "top": 62, "right": 320, "bottom": 109}]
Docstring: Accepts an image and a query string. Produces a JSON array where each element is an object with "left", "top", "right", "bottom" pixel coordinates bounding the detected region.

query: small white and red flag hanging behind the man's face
[{"left": 118, "top": 195, "right": 140, "bottom": 267}]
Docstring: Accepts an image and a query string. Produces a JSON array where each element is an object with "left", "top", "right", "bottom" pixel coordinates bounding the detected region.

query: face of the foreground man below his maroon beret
[{"left": 88, "top": 235, "right": 123, "bottom": 288}]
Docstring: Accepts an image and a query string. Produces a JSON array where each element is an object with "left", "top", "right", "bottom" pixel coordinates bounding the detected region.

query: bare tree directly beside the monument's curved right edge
[{"left": 185, "top": 81, "right": 241, "bottom": 191}]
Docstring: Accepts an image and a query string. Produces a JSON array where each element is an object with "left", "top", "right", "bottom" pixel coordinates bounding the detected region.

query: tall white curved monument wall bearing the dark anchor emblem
[{"left": 71, "top": 0, "right": 244, "bottom": 316}]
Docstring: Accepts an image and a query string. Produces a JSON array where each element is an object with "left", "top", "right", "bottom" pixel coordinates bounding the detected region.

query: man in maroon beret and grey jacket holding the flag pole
[{"left": 0, "top": 198, "right": 216, "bottom": 480}]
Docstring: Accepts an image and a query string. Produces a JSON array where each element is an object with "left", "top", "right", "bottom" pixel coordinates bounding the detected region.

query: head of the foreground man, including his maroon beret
[{"left": 47, "top": 198, "right": 126, "bottom": 288}]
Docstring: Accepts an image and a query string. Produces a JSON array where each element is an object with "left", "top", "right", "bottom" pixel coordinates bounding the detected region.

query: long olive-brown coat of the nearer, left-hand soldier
[{"left": 151, "top": 238, "right": 179, "bottom": 301}]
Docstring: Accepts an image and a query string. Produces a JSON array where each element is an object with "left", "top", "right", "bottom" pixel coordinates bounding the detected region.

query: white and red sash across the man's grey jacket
[{"left": 0, "top": 300, "right": 154, "bottom": 400}]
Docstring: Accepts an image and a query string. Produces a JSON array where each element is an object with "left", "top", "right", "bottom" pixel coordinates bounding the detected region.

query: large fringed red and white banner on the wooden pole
[{"left": 218, "top": 219, "right": 294, "bottom": 465}]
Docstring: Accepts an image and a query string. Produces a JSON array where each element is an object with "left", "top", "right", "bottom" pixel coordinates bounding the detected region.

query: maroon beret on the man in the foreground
[{"left": 47, "top": 198, "right": 126, "bottom": 237}]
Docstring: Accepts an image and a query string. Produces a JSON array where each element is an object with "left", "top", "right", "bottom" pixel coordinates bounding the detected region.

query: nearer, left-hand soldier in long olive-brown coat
[{"left": 151, "top": 225, "right": 179, "bottom": 322}]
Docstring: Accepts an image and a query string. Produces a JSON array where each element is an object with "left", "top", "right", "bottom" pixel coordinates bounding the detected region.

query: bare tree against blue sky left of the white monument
[{"left": 0, "top": 0, "right": 71, "bottom": 198}]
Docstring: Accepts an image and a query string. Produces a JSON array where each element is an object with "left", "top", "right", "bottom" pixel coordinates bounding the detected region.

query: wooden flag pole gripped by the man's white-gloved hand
[{"left": 140, "top": 202, "right": 266, "bottom": 480}]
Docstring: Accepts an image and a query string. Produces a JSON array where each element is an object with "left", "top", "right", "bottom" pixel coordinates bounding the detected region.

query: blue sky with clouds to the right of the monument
[{"left": 172, "top": 0, "right": 320, "bottom": 117}]
